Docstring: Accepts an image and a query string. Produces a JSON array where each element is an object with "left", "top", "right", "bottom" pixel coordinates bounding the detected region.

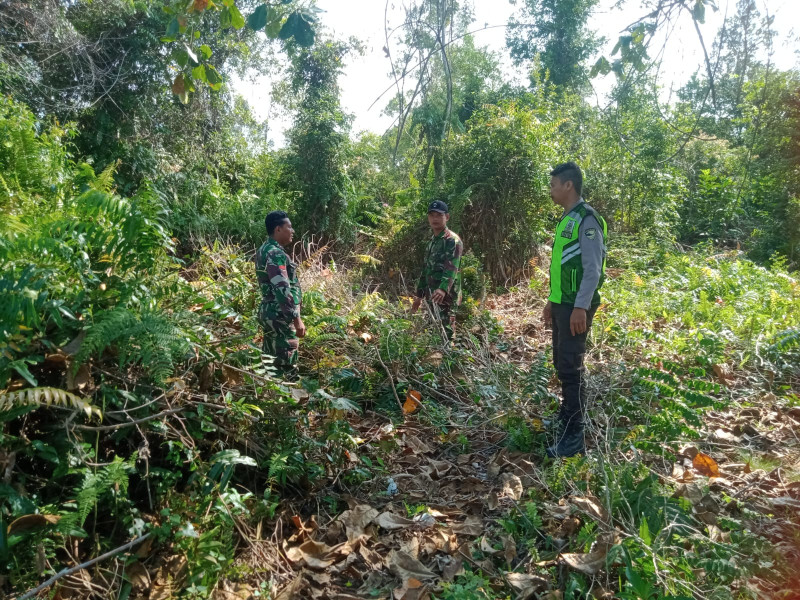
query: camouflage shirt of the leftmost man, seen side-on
[{"left": 255, "top": 238, "right": 303, "bottom": 322}]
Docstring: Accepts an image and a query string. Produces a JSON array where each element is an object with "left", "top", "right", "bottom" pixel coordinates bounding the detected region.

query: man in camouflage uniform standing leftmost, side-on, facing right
[{"left": 255, "top": 210, "right": 306, "bottom": 380}]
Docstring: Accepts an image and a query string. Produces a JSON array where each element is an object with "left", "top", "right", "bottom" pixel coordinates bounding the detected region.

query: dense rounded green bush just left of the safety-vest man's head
[{"left": 447, "top": 103, "right": 558, "bottom": 284}]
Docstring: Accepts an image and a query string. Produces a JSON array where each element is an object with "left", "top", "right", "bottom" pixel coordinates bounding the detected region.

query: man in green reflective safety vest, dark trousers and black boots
[{"left": 542, "top": 162, "right": 608, "bottom": 458}]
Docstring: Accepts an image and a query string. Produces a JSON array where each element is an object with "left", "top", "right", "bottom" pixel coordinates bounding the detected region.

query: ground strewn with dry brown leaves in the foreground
[{"left": 194, "top": 276, "right": 800, "bottom": 600}]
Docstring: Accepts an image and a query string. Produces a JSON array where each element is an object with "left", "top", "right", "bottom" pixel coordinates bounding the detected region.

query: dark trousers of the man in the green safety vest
[{"left": 552, "top": 304, "right": 597, "bottom": 433}]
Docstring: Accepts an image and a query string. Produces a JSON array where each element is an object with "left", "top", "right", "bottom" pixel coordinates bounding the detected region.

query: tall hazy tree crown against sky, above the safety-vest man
[{"left": 506, "top": 0, "right": 602, "bottom": 92}]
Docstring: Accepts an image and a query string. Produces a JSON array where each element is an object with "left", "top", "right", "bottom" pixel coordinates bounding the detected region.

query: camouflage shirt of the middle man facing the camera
[{"left": 417, "top": 228, "right": 464, "bottom": 304}]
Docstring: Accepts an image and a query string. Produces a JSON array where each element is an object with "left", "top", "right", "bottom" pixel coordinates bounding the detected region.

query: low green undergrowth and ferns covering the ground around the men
[{"left": 0, "top": 99, "right": 800, "bottom": 600}]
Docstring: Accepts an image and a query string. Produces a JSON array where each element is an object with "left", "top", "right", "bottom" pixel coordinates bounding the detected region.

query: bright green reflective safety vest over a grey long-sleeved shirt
[{"left": 548, "top": 202, "right": 608, "bottom": 306}]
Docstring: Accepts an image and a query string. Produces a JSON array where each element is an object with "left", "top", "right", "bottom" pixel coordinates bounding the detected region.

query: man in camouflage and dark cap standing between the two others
[{"left": 411, "top": 200, "right": 464, "bottom": 338}]
